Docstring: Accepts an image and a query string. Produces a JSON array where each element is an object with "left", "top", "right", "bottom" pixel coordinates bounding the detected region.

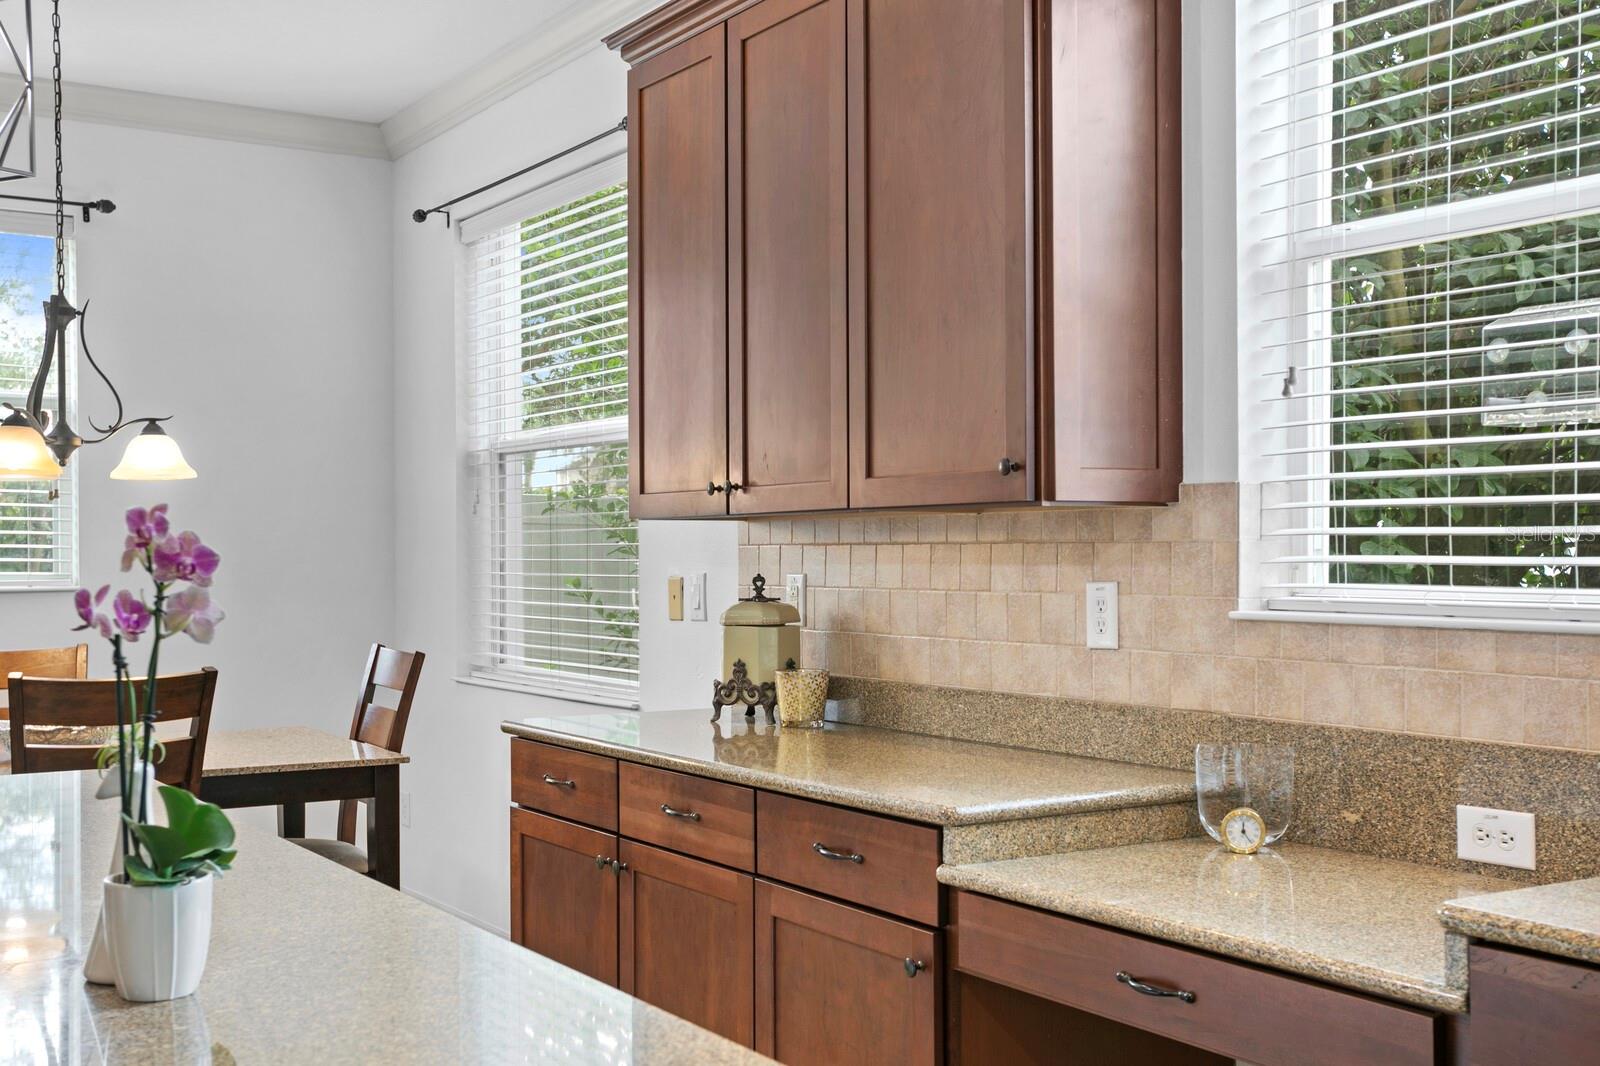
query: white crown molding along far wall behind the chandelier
[{"left": 0, "top": 77, "right": 389, "bottom": 158}]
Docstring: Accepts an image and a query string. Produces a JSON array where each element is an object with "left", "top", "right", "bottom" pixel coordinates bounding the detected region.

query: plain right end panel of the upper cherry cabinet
[{"left": 1038, "top": 0, "right": 1182, "bottom": 503}]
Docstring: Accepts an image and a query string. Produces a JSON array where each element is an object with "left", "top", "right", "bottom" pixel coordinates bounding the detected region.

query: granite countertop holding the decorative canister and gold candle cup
[{"left": 505, "top": 709, "right": 1194, "bottom": 826}]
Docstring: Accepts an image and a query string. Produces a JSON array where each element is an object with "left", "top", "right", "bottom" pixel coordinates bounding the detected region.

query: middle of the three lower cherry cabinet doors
[{"left": 619, "top": 840, "right": 755, "bottom": 1047}]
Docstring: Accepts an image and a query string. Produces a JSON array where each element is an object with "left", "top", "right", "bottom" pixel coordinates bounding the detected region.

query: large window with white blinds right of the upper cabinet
[{"left": 1238, "top": 0, "right": 1600, "bottom": 623}]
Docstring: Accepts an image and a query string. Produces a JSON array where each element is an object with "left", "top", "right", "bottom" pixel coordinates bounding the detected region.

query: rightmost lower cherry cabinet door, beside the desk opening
[{"left": 755, "top": 880, "right": 942, "bottom": 1066}]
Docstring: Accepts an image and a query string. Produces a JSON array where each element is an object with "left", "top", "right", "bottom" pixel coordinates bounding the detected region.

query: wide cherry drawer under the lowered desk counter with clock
[{"left": 950, "top": 892, "right": 1440, "bottom": 1066}]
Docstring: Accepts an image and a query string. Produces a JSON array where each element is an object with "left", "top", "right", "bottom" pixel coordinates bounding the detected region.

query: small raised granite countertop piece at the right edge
[{"left": 1438, "top": 877, "right": 1600, "bottom": 964}]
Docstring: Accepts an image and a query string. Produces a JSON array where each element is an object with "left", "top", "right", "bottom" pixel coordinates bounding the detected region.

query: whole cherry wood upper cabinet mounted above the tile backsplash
[{"left": 608, "top": 0, "right": 1182, "bottom": 517}]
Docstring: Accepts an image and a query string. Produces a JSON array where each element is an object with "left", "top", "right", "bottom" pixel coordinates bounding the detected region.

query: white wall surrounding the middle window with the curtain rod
[{"left": 390, "top": 45, "right": 738, "bottom": 930}]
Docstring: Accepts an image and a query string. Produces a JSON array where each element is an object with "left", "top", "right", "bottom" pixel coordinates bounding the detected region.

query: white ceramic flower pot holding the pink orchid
[{"left": 104, "top": 874, "right": 213, "bottom": 1002}]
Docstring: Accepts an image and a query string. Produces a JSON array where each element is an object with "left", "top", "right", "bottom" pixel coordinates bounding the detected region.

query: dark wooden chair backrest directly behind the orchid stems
[{"left": 6, "top": 666, "right": 216, "bottom": 795}]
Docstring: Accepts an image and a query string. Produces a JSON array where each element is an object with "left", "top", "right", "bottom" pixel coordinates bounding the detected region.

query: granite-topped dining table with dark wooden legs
[{"left": 0, "top": 713, "right": 410, "bottom": 888}]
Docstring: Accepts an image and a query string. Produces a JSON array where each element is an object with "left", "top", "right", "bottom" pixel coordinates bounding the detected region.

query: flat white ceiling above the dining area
[{"left": 43, "top": 0, "right": 590, "bottom": 122}]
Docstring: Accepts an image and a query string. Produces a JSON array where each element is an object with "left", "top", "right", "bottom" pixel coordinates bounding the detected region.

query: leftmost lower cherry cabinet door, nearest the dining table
[{"left": 510, "top": 807, "right": 618, "bottom": 984}]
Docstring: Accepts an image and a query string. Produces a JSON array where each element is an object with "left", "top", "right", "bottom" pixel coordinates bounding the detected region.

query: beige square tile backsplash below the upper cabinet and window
[{"left": 739, "top": 483, "right": 1600, "bottom": 751}]
